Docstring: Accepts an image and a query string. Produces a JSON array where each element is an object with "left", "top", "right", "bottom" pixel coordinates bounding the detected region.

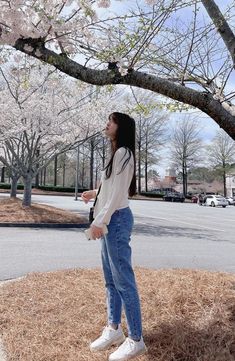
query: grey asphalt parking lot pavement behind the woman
[{"left": 0, "top": 195, "right": 235, "bottom": 280}]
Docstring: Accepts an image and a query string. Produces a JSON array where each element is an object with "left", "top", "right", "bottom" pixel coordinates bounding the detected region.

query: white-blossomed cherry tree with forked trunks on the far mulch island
[{"left": 0, "top": 62, "right": 114, "bottom": 206}]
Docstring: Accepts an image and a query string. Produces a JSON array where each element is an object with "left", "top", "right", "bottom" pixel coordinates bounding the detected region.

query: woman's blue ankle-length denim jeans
[{"left": 101, "top": 207, "right": 142, "bottom": 340}]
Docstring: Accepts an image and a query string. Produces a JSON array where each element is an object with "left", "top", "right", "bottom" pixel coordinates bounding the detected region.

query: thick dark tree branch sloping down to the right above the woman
[{"left": 14, "top": 38, "right": 235, "bottom": 140}]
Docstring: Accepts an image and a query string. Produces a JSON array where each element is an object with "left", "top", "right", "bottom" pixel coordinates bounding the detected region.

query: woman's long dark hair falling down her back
[{"left": 104, "top": 112, "right": 136, "bottom": 197}]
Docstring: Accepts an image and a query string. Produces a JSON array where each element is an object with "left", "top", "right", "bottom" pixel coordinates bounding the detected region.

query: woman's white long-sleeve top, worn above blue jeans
[{"left": 92, "top": 147, "right": 134, "bottom": 227}]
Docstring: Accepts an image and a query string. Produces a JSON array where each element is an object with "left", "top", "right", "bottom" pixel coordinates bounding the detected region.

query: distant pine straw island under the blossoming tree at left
[{"left": 0, "top": 198, "right": 87, "bottom": 223}]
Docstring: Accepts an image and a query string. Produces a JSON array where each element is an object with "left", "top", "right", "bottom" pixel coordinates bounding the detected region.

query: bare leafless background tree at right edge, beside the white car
[{"left": 207, "top": 130, "right": 235, "bottom": 197}]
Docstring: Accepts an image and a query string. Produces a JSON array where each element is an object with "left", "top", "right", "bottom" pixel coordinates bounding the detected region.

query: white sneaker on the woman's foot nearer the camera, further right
[{"left": 109, "top": 337, "right": 147, "bottom": 361}]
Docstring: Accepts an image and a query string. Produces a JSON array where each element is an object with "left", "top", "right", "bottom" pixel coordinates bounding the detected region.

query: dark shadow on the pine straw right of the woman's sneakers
[{"left": 145, "top": 320, "right": 235, "bottom": 361}]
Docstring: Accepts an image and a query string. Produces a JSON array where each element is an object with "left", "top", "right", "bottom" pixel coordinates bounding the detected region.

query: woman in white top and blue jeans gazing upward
[{"left": 82, "top": 112, "right": 147, "bottom": 361}]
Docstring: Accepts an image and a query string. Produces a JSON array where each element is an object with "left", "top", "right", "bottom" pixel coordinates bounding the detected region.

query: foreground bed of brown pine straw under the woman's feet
[{"left": 0, "top": 269, "right": 235, "bottom": 361}]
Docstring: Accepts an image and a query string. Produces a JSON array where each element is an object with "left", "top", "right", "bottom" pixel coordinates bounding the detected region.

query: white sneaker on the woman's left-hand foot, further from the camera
[{"left": 90, "top": 325, "right": 125, "bottom": 351}]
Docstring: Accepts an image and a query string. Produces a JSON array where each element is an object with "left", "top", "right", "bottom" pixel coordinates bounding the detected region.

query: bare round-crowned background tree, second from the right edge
[{"left": 170, "top": 117, "right": 202, "bottom": 196}]
